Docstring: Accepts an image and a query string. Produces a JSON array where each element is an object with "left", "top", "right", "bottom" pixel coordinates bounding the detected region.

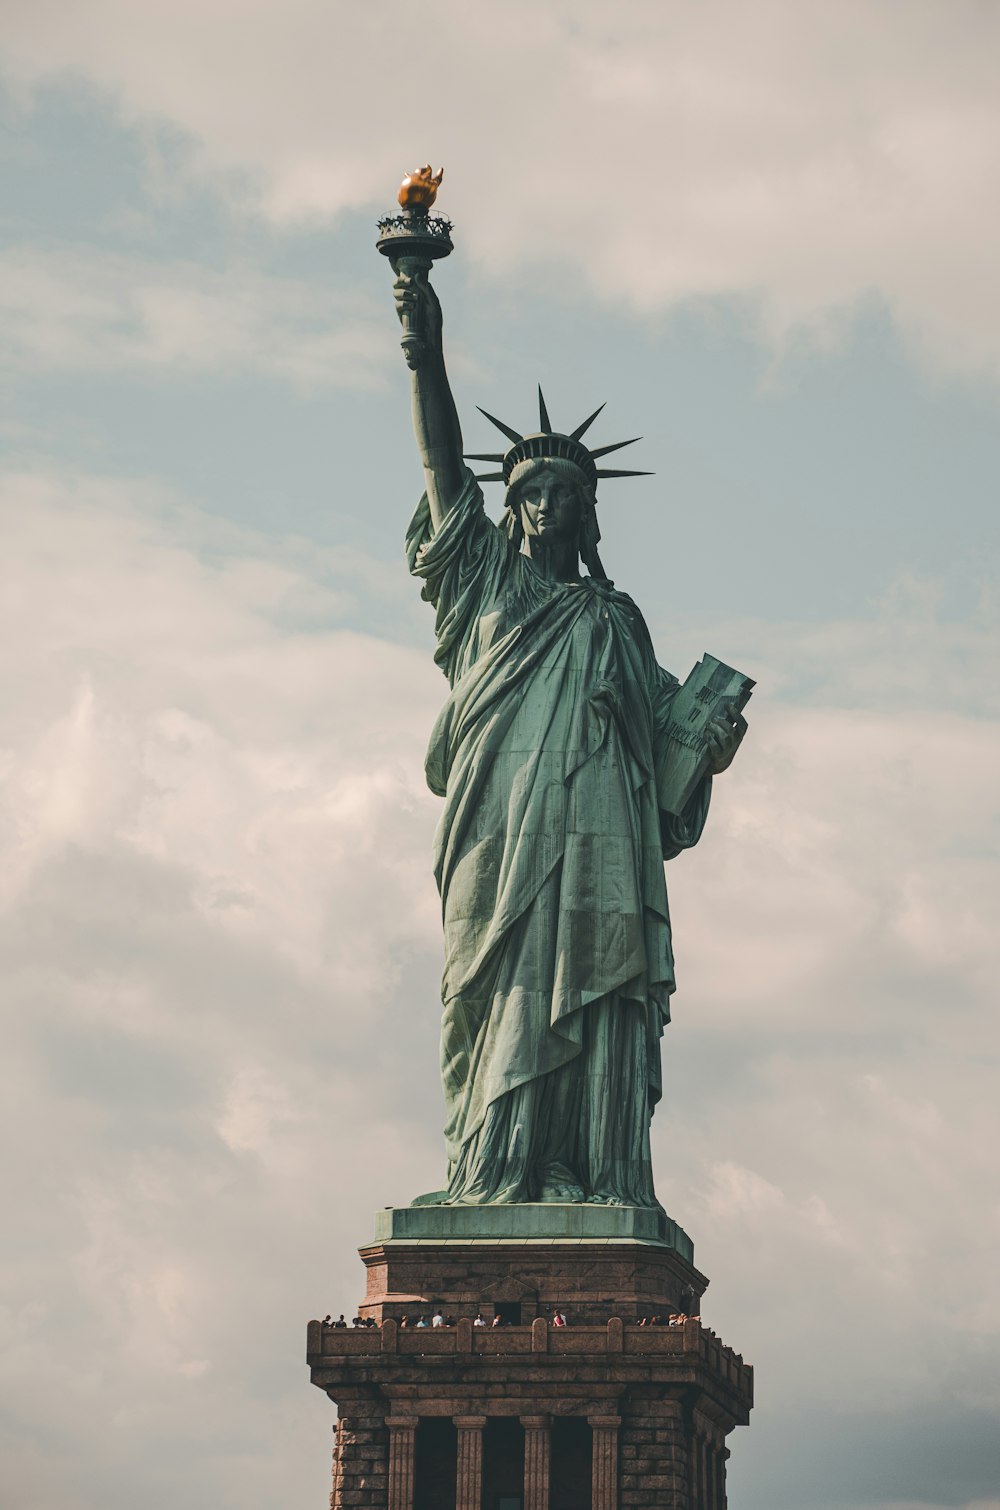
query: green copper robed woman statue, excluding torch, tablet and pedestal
[{"left": 394, "top": 272, "right": 746, "bottom": 1208}]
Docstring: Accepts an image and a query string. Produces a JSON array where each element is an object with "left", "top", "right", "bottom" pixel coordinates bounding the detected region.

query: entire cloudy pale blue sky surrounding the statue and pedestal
[{"left": 0, "top": 0, "right": 1000, "bottom": 1510}]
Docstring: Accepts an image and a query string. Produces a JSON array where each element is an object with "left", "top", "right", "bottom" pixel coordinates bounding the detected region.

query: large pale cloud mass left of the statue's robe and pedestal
[{"left": 0, "top": 476, "right": 453, "bottom": 1510}]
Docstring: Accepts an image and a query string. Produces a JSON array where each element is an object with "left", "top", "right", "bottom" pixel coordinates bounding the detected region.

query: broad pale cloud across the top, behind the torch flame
[{"left": 6, "top": 0, "right": 1000, "bottom": 378}]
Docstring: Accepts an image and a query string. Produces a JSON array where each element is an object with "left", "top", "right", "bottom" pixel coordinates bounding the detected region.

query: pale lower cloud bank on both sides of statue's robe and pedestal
[{"left": 0, "top": 474, "right": 1000, "bottom": 1510}]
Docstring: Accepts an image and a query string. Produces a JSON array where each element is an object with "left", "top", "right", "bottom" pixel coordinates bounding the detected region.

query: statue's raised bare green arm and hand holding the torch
[{"left": 394, "top": 269, "right": 465, "bottom": 530}]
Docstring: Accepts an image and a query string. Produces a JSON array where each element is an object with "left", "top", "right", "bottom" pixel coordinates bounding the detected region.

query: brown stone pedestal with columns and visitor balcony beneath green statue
[{"left": 308, "top": 1208, "right": 752, "bottom": 1510}]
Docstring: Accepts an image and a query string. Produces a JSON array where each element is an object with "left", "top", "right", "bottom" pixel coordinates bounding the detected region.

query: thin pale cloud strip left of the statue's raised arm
[{"left": 0, "top": 245, "right": 387, "bottom": 388}]
